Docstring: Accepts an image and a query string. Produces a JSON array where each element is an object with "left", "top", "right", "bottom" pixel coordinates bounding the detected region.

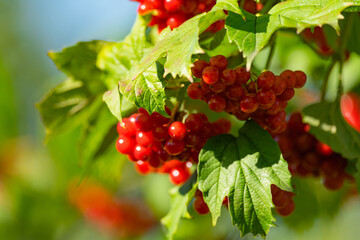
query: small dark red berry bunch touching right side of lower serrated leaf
[{"left": 271, "top": 185, "right": 295, "bottom": 217}]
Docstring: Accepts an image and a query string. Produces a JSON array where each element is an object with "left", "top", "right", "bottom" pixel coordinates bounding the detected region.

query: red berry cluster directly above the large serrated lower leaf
[{"left": 187, "top": 55, "right": 306, "bottom": 134}]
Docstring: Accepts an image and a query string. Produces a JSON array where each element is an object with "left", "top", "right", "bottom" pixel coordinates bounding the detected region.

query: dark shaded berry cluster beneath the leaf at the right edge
[{"left": 275, "top": 113, "right": 350, "bottom": 190}]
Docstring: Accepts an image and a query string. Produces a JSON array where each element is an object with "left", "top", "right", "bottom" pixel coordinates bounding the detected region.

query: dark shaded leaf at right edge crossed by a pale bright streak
[{"left": 303, "top": 100, "right": 360, "bottom": 160}]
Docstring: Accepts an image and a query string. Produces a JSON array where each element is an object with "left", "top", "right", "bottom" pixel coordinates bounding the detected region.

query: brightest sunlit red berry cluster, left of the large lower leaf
[{"left": 116, "top": 108, "right": 231, "bottom": 184}]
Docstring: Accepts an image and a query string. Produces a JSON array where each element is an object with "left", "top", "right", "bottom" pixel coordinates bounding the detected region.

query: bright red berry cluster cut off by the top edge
[{"left": 135, "top": 0, "right": 215, "bottom": 32}]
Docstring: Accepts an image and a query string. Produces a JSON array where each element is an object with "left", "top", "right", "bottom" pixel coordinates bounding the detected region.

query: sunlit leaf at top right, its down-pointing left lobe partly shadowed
[{"left": 225, "top": 0, "right": 352, "bottom": 69}]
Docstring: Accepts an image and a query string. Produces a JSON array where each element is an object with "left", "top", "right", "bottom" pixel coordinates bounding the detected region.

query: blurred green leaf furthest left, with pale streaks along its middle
[{"left": 37, "top": 78, "right": 102, "bottom": 139}]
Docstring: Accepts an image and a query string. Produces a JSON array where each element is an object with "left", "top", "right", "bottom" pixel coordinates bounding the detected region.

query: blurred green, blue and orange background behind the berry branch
[{"left": 0, "top": 0, "right": 360, "bottom": 240}]
